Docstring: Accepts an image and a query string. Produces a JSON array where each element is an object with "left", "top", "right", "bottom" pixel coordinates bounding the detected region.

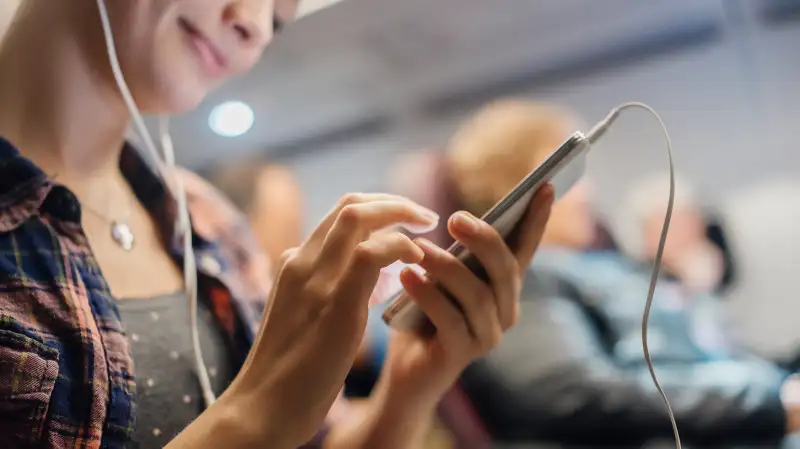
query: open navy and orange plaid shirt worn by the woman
[{"left": 0, "top": 139, "right": 344, "bottom": 448}]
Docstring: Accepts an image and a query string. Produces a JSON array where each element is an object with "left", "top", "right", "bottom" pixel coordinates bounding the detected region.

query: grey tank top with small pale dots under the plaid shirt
[{"left": 118, "top": 292, "right": 236, "bottom": 449}]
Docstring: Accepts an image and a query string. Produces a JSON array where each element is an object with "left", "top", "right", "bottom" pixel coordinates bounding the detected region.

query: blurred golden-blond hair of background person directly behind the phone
[{"left": 447, "top": 99, "right": 579, "bottom": 215}]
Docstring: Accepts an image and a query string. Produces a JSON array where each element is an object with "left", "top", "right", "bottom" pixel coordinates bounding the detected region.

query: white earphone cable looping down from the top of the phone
[{"left": 586, "top": 102, "right": 682, "bottom": 449}]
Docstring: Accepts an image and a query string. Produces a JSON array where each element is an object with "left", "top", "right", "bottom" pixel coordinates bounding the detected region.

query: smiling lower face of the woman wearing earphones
[{"left": 90, "top": 0, "right": 297, "bottom": 113}]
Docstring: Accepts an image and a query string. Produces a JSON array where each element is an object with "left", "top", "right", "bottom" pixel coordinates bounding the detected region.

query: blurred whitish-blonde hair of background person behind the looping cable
[{"left": 613, "top": 172, "right": 700, "bottom": 259}]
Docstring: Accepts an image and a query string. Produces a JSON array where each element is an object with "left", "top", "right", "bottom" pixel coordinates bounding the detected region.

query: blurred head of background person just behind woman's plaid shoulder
[{"left": 211, "top": 160, "right": 306, "bottom": 262}]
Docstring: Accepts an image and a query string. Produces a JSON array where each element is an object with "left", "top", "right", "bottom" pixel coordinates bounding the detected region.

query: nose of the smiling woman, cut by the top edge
[{"left": 222, "top": 0, "right": 272, "bottom": 47}]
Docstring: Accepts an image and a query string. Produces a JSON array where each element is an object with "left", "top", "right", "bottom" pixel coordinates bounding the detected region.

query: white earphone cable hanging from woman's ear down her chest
[{"left": 97, "top": 0, "right": 216, "bottom": 407}]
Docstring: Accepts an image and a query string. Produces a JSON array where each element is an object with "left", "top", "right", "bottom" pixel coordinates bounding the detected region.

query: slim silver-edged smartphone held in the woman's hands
[{"left": 383, "top": 132, "right": 590, "bottom": 334}]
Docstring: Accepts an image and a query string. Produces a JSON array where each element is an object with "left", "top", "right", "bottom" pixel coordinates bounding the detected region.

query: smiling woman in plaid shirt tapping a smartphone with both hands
[{"left": 0, "top": 0, "right": 552, "bottom": 448}]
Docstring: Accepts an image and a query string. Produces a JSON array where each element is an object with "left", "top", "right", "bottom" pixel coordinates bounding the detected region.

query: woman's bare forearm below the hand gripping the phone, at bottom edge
[{"left": 325, "top": 381, "right": 438, "bottom": 449}]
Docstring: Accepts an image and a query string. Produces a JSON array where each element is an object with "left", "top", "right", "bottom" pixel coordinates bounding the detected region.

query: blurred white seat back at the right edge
[{"left": 721, "top": 179, "right": 800, "bottom": 362}]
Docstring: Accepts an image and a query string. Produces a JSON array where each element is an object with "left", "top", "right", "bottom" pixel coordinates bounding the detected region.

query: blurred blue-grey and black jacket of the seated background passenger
[{"left": 463, "top": 250, "right": 787, "bottom": 447}]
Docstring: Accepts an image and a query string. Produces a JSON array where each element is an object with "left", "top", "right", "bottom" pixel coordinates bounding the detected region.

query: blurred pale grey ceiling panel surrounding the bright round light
[{"left": 173, "top": 0, "right": 724, "bottom": 168}]
